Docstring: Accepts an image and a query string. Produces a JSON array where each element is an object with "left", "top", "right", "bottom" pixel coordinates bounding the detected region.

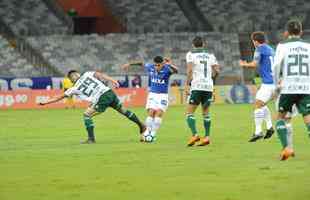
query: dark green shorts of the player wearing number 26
[{"left": 279, "top": 94, "right": 310, "bottom": 116}]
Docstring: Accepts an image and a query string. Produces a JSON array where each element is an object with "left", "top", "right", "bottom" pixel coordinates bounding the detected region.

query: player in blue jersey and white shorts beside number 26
[{"left": 240, "top": 32, "right": 275, "bottom": 142}]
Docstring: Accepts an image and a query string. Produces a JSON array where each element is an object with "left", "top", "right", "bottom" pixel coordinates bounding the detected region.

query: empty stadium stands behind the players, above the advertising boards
[{"left": 0, "top": 0, "right": 310, "bottom": 84}]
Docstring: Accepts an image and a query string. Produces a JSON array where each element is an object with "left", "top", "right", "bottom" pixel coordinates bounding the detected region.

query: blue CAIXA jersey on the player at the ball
[{"left": 144, "top": 63, "right": 172, "bottom": 93}]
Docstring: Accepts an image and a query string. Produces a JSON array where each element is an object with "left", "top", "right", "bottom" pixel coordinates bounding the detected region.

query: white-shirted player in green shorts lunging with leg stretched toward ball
[{"left": 40, "top": 70, "right": 146, "bottom": 144}]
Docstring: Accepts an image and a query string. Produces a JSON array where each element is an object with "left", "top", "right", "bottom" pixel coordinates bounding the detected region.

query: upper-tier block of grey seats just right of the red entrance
[{"left": 104, "top": 0, "right": 191, "bottom": 33}]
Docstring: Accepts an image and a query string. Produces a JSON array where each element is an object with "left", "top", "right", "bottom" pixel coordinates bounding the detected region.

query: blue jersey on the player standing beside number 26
[{"left": 254, "top": 44, "right": 274, "bottom": 84}]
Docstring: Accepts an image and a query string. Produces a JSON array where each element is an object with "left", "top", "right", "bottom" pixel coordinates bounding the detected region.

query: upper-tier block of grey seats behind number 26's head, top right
[{"left": 197, "top": 0, "right": 310, "bottom": 32}]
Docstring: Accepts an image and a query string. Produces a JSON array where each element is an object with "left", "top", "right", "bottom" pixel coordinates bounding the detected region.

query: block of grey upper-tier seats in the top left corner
[{"left": 0, "top": 0, "right": 70, "bottom": 36}]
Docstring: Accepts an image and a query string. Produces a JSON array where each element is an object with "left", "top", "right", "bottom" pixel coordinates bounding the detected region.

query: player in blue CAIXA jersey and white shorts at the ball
[{"left": 122, "top": 56, "right": 178, "bottom": 141}]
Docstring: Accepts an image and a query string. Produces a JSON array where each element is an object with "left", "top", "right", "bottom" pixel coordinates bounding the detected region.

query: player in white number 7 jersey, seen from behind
[{"left": 185, "top": 37, "right": 219, "bottom": 146}]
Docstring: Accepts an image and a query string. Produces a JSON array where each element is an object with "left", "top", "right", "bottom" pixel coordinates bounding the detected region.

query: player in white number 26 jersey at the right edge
[{"left": 274, "top": 20, "right": 310, "bottom": 160}]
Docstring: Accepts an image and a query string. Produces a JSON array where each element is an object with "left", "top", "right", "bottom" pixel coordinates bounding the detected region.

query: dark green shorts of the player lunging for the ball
[{"left": 94, "top": 90, "right": 122, "bottom": 112}]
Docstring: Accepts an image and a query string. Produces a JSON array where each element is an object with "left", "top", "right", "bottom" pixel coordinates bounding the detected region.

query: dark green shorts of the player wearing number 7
[{"left": 188, "top": 90, "right": 213, "bottom": 108}]
